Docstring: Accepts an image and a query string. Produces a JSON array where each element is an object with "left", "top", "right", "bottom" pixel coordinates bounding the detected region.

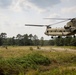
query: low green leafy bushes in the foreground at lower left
[{"left": 0, "top": 53, "right": 50, "bottom": 75}]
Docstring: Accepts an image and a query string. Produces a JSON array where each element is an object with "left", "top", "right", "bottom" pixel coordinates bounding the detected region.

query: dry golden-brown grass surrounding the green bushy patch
[{"left": 0, "top": 46, "right": 76, "bottom": 75}]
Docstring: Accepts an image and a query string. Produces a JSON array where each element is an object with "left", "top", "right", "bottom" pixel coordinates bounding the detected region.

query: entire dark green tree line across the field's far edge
[{"left": 0, "top": 33, "right": 76, "bottom": 46}]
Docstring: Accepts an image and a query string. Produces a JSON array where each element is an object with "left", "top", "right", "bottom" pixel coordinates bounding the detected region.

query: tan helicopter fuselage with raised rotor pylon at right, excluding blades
[{"left": 45, "top": 18, "right": 76, "bottom": 36}]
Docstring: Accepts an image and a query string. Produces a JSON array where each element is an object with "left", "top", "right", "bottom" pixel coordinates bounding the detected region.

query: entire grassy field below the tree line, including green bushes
[{"left": 0, "top": 46, "right": 76, "bottom": 75}]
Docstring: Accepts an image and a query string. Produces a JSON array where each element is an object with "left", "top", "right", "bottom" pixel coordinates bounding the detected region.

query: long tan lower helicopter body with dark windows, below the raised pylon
[{"left": 45, "top": 28, "right": 76, "bottom": 36}]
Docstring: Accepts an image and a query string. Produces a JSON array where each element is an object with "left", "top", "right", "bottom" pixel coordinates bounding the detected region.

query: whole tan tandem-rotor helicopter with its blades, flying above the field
[{"left": 25, "top": 18, "right": 76, "bottom": 38}]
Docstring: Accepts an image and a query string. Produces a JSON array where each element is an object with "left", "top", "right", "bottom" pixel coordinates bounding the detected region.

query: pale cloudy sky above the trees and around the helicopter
[{"left": 0, "top": 0, "right": 76, "bottom": 39}]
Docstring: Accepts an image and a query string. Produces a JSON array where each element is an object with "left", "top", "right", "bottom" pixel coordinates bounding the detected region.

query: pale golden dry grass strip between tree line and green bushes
[{"left": 0, "top": 46, "right": 76, "bottom": 58}]
